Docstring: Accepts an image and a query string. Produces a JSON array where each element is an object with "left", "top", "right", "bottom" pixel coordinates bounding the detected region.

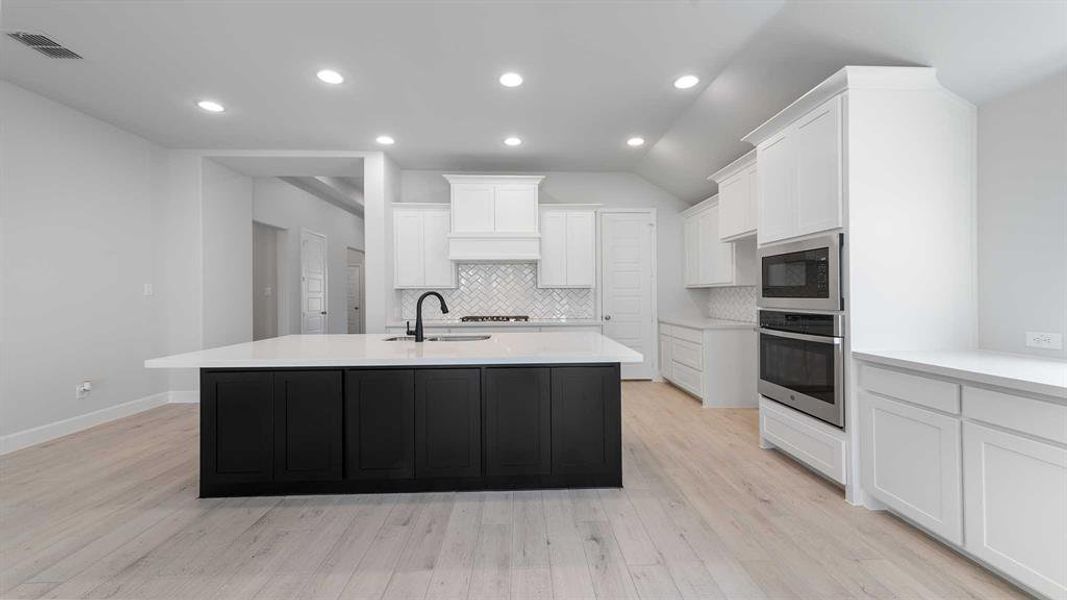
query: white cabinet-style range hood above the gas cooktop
[{"left": 444, "top": 174, "right": 544, "bottom": 258}]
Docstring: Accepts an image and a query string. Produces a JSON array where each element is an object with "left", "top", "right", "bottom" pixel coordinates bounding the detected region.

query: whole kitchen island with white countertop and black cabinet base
[{"left": 145, "top": 331, "right": 642, "bottom": 498}]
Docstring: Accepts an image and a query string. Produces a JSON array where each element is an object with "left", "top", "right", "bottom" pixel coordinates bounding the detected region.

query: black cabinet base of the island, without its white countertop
[{"left": 201, "top": 364, "right": 622, "bottom": 498}]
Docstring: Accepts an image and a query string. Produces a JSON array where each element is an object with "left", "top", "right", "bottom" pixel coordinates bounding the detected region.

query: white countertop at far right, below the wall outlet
[{"left": 853, "top": 350, "right": 1067, "bottom": 398}]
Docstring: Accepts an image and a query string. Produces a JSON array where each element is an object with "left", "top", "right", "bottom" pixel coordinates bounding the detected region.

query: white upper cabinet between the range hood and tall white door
[{"left": 538, "top": 205, "right": 596, "bottom": 287}]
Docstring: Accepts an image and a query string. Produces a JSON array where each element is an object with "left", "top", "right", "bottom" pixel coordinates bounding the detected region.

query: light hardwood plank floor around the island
[{"left": 0, "top": 382, "right": 1022, "bottom": 600}]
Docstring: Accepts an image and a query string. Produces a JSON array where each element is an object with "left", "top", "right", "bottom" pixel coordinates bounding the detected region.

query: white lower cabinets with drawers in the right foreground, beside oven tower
[{"left": 857, "top": 362, "right": 1067, "bottom": 600}]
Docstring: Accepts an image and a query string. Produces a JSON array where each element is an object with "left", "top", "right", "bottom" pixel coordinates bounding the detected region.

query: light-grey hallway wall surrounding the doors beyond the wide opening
[{"left": 253, "top": 177, "right": 364, "bottom": 335}]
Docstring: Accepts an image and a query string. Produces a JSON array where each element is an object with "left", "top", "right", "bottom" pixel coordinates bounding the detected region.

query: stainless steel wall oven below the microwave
[{"left": 759, "top": 311, "right": 845, "bottom": 428}]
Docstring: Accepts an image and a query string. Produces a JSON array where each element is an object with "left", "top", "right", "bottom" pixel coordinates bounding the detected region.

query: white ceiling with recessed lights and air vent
[{"left": 0, "top": 0, "right": 1067, "bottom": 202}]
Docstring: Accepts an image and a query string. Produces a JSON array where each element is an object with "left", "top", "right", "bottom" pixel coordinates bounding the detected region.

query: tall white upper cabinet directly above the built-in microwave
[{"left": 757, "top": 95, "right": 843, "bottom": 243}]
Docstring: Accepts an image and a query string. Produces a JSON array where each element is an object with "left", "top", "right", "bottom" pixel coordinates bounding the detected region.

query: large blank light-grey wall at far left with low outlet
[{"left": 0, "top": 81, "right": 168, "bottom": 439}]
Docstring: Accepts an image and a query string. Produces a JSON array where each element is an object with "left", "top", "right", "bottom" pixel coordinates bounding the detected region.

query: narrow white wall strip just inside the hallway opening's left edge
[{"left": 201, "top": 159, "right": 252, "bottom": 348}]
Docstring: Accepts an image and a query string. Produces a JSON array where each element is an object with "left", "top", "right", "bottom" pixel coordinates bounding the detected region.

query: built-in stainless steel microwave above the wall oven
[{"left": 758, "top": 234, "right": 844, "bottom": 311}]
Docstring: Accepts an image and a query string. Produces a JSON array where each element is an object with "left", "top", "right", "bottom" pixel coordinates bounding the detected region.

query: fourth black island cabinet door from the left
[{"left": 415, "top": 368, "right": 481, "bottom": 479}]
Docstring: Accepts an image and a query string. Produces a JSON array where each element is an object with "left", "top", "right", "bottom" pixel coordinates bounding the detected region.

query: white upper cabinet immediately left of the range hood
[{"left": 393, "top": 204, "right": 456, "bottom": 288}]
